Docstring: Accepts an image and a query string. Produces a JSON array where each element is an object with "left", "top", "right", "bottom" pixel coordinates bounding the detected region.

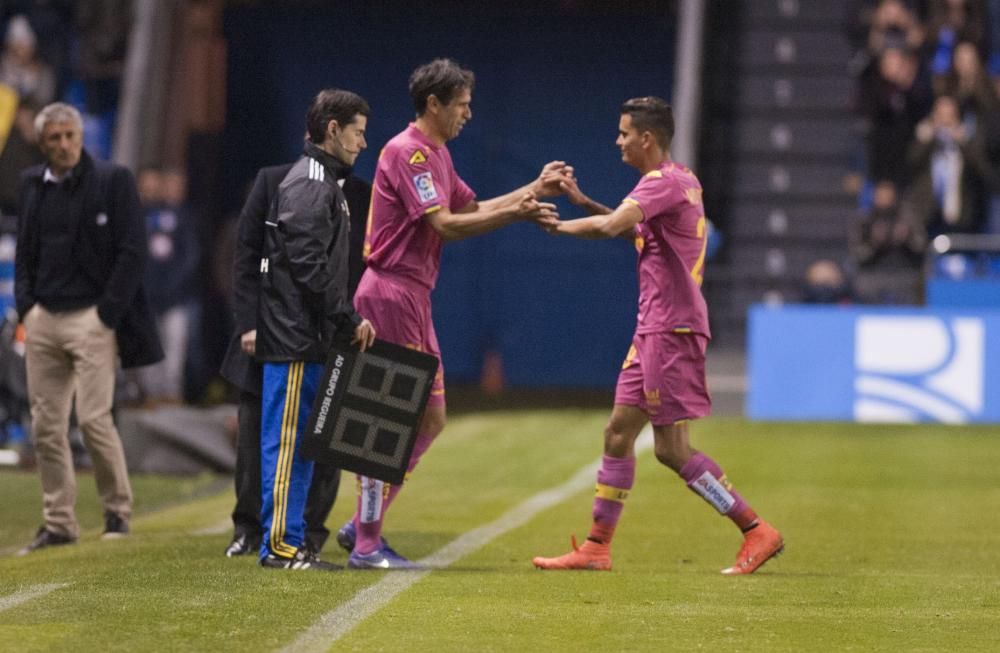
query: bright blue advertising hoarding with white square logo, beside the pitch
[{"left": 747, "top": 305, "right": 1000, "bottom": 424}]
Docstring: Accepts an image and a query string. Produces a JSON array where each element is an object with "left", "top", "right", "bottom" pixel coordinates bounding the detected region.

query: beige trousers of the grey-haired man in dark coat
[{"left": 24, "top": 304, "right": 132, "bottom": 538}]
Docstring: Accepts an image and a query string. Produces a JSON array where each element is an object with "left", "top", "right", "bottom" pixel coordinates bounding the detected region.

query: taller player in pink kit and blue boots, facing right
[{"left": 337, "top": 59, "right": 568, "bottom": 569}]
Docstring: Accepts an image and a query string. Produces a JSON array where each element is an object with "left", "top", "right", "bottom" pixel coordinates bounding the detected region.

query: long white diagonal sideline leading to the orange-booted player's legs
[{"left": 281, "top": 426, "right": 653, "bottom": 653}]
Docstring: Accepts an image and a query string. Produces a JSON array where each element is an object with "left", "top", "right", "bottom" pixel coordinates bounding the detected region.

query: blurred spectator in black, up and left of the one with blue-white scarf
[{"left": 862, "top": 47, "right": 933, "bottom": 186}]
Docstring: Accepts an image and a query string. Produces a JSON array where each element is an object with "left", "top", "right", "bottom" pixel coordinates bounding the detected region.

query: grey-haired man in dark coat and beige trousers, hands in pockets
[{"left": 14, "top": 103, "right": 163, "bottom": 554}]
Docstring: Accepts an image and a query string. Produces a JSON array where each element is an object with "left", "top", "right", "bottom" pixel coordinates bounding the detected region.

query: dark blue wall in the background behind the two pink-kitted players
[{"left": 224, "top": 2, "right": 675, "bottom": 387}]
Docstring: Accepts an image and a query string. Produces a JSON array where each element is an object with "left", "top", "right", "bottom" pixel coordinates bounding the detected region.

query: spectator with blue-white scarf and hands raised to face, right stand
[{"left": 908, "top": 95, "right": 997, "bottom": 236}]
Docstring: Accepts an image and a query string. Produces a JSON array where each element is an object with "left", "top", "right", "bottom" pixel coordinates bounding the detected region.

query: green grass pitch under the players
[{"left": 0, "top": 410, "right": 1000, "bottom": 653}]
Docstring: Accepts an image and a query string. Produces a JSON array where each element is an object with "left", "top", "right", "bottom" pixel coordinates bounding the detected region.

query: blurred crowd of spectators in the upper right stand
[{"left": 845, "top": 0, "right": 1000, "bottom": 304}]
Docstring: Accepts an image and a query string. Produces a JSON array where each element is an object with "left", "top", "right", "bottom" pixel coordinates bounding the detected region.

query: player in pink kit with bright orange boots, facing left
[{"left": 533, "top": 97, "right": 784, "bottom": 574}]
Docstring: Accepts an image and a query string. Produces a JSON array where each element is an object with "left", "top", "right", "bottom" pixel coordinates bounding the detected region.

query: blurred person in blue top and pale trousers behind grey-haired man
[{"left": 139, "top": 170, "right": 199, "bottom": 403}]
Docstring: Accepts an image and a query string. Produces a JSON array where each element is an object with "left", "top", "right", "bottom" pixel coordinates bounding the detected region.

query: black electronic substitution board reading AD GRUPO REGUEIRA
[{"left": 302, "top": 340, "right": 438, "bottom": 485}]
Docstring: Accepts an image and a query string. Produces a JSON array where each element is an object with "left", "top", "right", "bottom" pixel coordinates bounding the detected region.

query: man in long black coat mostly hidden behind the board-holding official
[{"left": 222, "top": 149, "right": 372, "bottom": 557}]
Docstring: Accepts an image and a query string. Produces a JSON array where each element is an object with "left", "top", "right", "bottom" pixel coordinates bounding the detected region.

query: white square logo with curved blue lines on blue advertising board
[{"left": 854, "top": 316, "right": 986, "bottom": 424}]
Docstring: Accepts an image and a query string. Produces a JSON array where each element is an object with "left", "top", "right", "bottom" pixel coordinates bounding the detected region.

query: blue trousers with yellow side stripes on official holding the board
[{"left": 260, "top": 361, "right": 323, "bottom": 559}]
